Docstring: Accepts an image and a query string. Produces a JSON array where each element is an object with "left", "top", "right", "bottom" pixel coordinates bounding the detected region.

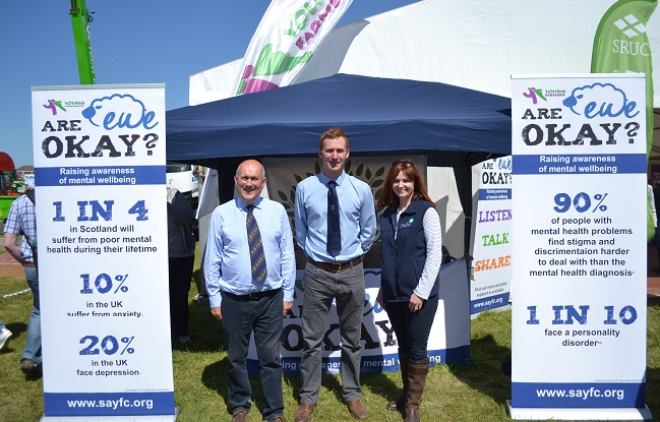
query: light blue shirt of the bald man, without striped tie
[{"left": 204, "top": 198, "right": 296, "bottom": 308}]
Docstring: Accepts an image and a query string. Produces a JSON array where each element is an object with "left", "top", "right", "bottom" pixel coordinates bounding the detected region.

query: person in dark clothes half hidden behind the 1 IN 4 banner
[{"left": 167, "top": 188, "right": 195, "bottom": 344}]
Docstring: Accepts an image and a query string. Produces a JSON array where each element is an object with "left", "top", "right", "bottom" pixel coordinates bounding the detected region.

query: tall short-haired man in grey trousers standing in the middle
[{"left": 295, "top": 128, "right": 376, "bottom": 422}]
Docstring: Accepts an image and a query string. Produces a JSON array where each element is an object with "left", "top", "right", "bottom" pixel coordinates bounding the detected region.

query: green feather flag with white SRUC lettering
[{"left": 591, "top": 0, "right": 658, "bottom": 240}]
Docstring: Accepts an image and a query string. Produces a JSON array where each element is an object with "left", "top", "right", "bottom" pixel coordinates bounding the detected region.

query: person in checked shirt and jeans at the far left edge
[{"left": 4, "top": 181, "right": 42, "bottom": 374}]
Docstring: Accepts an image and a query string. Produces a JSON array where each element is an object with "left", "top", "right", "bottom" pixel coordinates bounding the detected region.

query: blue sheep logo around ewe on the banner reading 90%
[{"left": 563, "top": 83, "right": 639, "bottom": 119}]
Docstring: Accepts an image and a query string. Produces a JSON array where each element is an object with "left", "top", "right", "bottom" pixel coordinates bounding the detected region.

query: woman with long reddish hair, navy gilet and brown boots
[{"left": 377, "top": 159, "right": 442, "bottom": 422}]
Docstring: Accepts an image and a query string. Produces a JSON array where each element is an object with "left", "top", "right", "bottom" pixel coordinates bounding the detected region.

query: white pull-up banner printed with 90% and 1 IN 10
[{"left": 510, "top": 74, "right": 650, "bottom": 420}]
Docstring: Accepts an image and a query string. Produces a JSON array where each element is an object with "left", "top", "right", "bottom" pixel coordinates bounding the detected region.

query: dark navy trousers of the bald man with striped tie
[{"left": 222, "top": 290, "right": 284, "bottom": 420}]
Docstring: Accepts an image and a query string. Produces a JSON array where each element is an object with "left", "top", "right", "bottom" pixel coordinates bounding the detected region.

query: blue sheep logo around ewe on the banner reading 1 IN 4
[{"left": 82, "top": 94, "right": 158, "bottom": 130}]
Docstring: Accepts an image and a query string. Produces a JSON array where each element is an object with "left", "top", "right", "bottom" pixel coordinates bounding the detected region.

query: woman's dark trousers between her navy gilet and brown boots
[{"left": 386, "top": 298, "right": 438, "bottom": 362}]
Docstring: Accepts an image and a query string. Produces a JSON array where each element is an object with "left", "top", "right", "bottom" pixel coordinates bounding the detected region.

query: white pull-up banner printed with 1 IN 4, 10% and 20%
[{"left": 32, "top": 84, "right": 175, "bottom": 421}]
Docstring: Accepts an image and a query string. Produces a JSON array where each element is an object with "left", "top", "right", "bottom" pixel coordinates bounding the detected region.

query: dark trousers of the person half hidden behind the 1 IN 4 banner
[{"left": 169, "top": 255, "right": 195, "bottom": 337}]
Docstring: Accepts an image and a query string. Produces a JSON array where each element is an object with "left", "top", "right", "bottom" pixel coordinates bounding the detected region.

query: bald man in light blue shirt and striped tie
[{"left": 204, "top": 160, "right": 296, "bottom": 422}]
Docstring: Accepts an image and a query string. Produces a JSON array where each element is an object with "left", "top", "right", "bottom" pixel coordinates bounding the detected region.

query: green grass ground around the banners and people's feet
[{"left": 0, "top": 266, "right": 660, "bottom": 422}]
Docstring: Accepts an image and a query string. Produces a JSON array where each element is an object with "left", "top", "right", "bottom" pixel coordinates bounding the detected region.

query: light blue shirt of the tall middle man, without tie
[{"left": 296, "top": 173, "right": 376, "bottom": 262}]
